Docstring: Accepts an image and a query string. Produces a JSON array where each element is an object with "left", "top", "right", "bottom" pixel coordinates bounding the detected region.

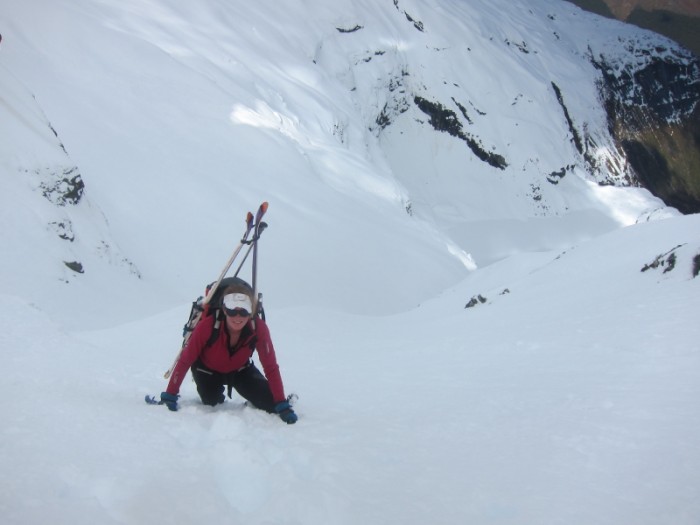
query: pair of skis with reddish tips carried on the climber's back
[{"left": 163, "top": 202, "right": 268, "bottom": 376}]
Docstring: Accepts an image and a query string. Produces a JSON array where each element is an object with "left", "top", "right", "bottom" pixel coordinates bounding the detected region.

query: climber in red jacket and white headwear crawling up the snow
[{"left": 160, "top": 277, "right": 297, "bottom": 424}]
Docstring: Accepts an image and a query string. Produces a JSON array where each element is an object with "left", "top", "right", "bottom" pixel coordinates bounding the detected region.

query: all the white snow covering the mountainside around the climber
[{"left": 0, "top": 0, "right": 700, "bottom": 525}]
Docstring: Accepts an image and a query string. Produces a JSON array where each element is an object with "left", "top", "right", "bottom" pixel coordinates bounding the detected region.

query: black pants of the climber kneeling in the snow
[{"left": 191, "top": 361, "right": 275, "bottom": 413}]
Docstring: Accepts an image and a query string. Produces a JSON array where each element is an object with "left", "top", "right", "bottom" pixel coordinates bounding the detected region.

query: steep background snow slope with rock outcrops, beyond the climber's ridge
[{"left": 0, "top": 0, "right": 674, "bottom": 322}]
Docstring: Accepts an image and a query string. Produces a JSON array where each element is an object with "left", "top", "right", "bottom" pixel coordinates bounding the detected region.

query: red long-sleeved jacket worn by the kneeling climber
[{"left": 166, "top": 315, "right": 286, "bottom": 403}]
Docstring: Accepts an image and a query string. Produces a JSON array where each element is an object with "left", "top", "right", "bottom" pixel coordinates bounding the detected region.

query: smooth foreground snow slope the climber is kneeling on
[{"left": 0, "top": 217, "right": 700, "bottom": 524}]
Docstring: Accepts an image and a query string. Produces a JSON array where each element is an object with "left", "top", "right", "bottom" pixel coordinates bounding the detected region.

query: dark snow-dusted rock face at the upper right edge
[{"left": 591, "top": 49, "right": 700, "bottom": 213}]
